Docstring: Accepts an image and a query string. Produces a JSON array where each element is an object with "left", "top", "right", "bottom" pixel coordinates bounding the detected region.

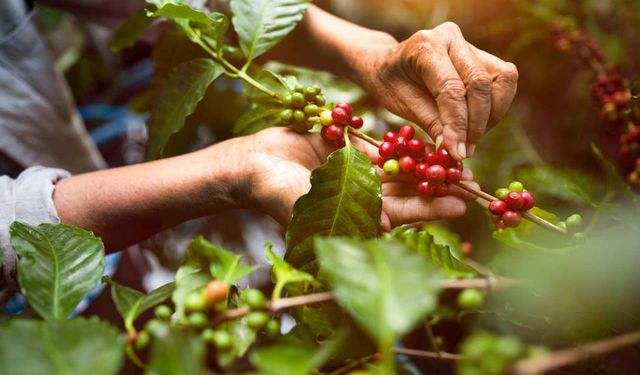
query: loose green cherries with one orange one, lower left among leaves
[{"left": 132, "top": 280, "right": 280, "bottom": 350}]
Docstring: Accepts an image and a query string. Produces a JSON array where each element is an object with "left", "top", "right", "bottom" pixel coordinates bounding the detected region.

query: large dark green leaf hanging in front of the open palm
[{"left": 285, "top": 144, "right": 382, "bottom": 274}]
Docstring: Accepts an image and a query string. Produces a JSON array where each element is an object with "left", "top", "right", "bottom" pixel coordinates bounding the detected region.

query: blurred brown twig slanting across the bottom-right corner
[{"left": 511, "top": 331, "right": 640, "bottom": 375}]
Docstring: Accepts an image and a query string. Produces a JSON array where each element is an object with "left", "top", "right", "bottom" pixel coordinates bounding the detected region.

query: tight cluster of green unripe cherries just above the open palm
[{"left": 280, "top": 85, "right": 326, "bottom": 133}]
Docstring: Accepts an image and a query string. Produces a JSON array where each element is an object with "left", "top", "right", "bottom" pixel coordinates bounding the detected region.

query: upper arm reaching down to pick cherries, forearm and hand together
[{"left": 264, "top": 5, "right": 518, "bottom": 159}]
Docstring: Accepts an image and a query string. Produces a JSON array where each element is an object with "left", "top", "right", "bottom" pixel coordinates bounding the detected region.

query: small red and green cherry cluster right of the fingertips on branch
[{"left": 489, "top": 181, "right": 535, "bottom": 229}]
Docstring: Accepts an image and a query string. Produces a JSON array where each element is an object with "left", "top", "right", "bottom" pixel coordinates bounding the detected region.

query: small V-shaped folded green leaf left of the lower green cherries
[{"left": 103, "top": 276, "right": 175, "bottom": 331}]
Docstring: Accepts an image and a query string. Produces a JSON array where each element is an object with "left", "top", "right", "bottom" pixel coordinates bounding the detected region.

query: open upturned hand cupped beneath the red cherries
[{"left": 246, "top": 128, "right": 474, "bottom": 230}]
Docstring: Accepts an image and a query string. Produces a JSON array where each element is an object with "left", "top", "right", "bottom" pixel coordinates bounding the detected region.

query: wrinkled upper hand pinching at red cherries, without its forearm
[{"left": 355, "top": 22, "right": 518, "bottom": 160}]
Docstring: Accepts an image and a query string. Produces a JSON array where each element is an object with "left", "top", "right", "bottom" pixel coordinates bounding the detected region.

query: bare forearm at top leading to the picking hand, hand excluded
[{"left": 267, "top": 5, "right": 398, "bottom": 81}]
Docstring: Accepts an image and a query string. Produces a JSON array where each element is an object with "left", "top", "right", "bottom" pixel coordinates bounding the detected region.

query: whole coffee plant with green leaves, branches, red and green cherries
[{"left": 0, "top": 0, "right": 640, "bottom": 375}]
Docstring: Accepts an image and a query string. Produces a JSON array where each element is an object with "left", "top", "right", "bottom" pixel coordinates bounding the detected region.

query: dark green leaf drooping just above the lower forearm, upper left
[{"left": 147, "top": 58, "right": 224, "bottom": 160}]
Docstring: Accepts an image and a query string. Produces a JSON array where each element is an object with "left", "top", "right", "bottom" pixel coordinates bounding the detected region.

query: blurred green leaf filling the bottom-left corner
[{"left": 0, "top": 318, "right": 124, "bottom": 375}]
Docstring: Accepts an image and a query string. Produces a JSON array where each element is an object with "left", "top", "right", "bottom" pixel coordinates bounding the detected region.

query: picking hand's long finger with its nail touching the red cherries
[{"left": 410, "top": 26, "right": 468, "bottom": 160}]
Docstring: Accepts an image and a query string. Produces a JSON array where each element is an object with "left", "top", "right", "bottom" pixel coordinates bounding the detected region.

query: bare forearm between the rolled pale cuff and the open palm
[{"left": 53, "top": 140, "right": 249, "bottom": 250}]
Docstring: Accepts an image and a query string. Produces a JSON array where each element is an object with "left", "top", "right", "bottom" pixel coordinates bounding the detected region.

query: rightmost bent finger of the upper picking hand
[{"left": 471, "top": 46, "right": 518, "bottom": 129}]
